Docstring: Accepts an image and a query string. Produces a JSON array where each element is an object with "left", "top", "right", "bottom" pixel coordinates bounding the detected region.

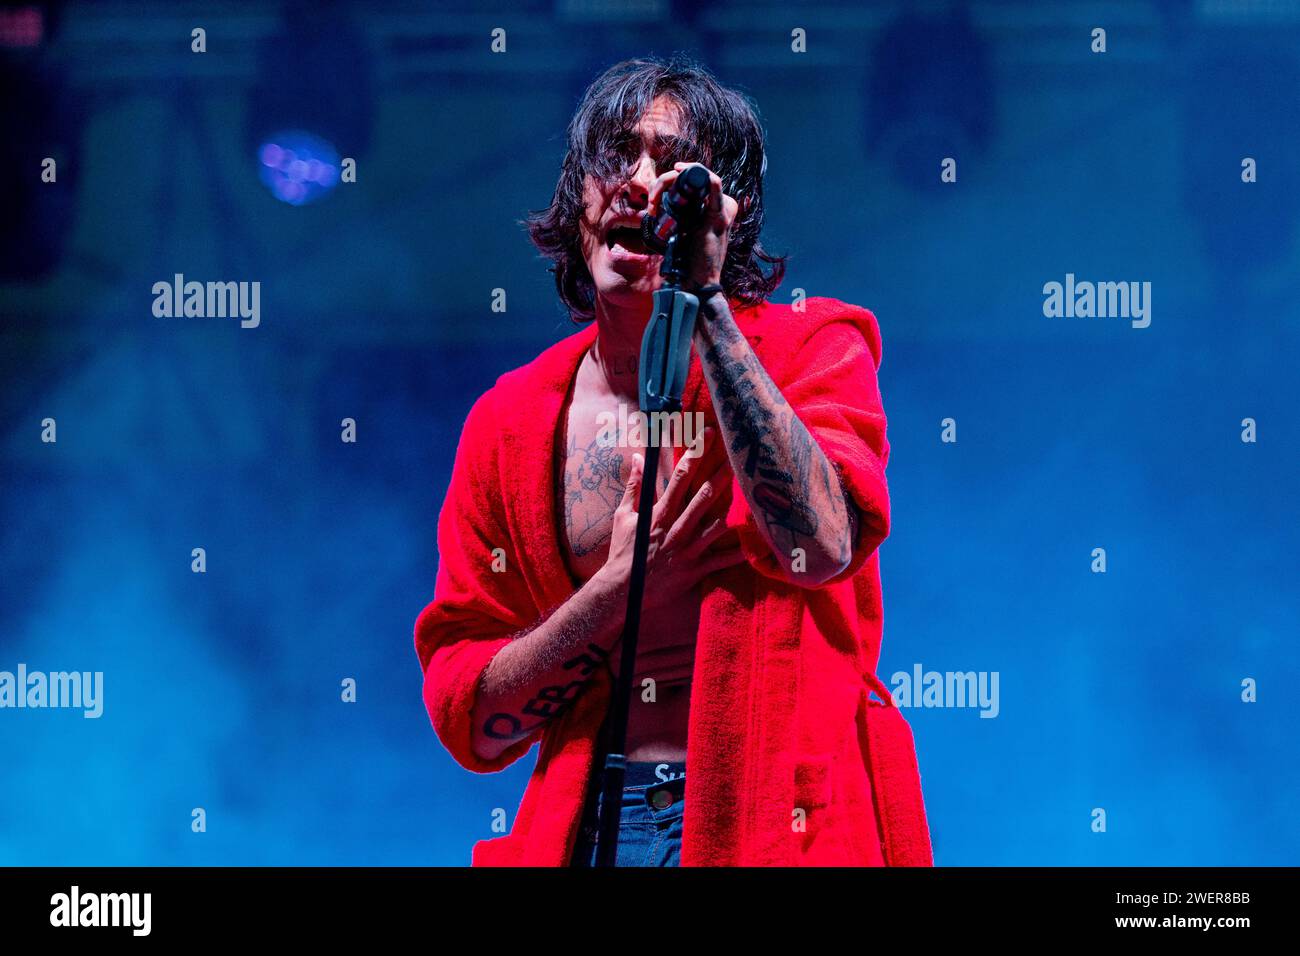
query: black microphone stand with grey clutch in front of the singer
[{"left": 595, "top": 218, "right": 707, "bottom": 866}]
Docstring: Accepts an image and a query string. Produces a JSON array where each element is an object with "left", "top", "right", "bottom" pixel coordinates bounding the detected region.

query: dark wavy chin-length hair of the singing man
[{"left": 524, "top": 55, "right": 785, "bottom": 323}]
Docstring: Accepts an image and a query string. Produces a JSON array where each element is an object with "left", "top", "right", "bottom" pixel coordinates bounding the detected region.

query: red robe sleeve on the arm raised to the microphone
[{"left": 727, "top": 299, "right": 889, "bottom": 588}]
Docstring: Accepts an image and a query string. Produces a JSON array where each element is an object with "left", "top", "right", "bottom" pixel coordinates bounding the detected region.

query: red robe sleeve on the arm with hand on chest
[{"left": 415, "top": 390, "right": 541, "bottom": 773}]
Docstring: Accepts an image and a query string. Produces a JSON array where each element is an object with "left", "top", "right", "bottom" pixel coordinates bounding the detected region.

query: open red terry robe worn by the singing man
[{"left": 415, "top": 298, "right": 932, "bottom": 866}]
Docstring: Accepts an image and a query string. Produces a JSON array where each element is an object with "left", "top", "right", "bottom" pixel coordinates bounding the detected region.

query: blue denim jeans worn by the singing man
[{"left": 573, "top": 762, "right": 686, "bottom": 866}]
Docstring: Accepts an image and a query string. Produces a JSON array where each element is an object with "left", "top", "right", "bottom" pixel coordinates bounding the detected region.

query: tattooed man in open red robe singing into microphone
[{"left": 415, "top": 59, "right": 931, "bottom": 866}]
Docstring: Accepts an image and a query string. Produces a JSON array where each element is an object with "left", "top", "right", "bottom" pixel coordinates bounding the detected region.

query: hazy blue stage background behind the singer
[{"left": 0, "top": 1, "right": 1300, "bottom": 865}]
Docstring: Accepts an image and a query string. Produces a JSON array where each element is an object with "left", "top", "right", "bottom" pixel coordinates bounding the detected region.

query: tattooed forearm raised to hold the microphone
[{"left": 696, "top": 297, "right": 855, "bottom": 583}]
